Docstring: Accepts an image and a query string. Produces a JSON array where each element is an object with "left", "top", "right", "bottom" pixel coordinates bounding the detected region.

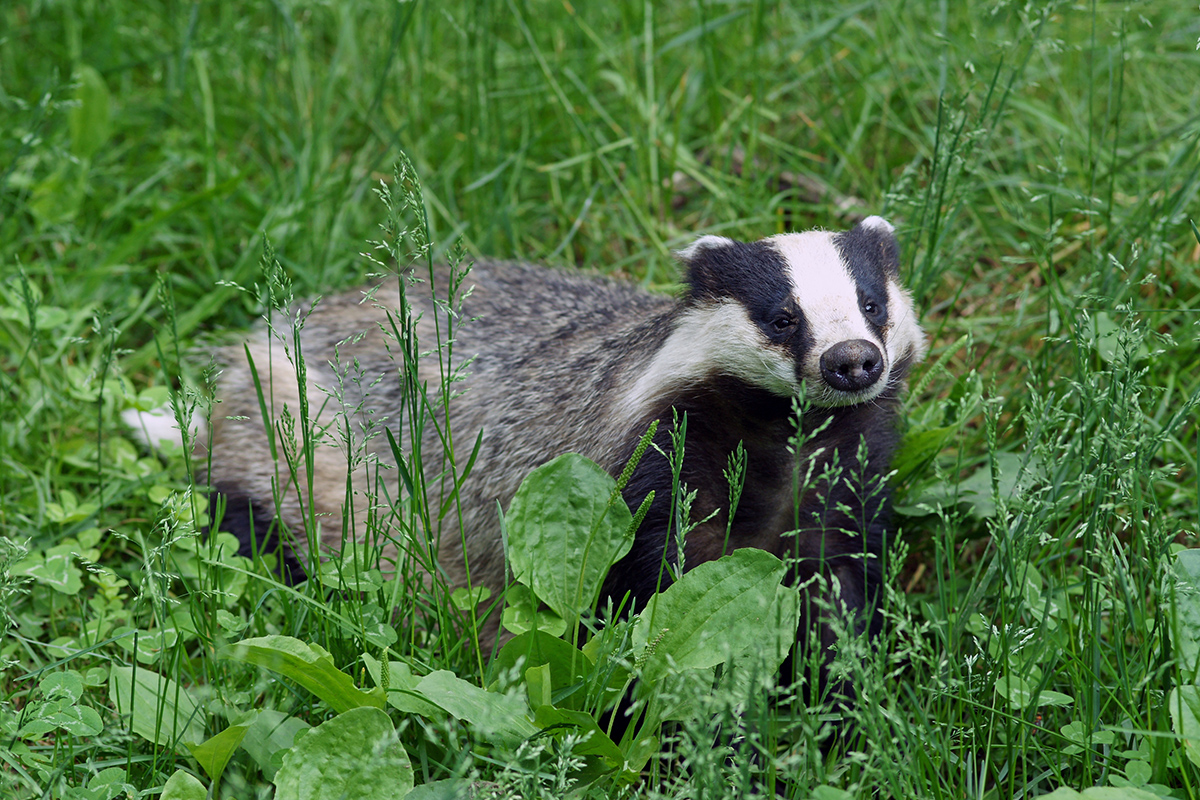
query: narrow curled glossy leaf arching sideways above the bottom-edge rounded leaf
[{"left": 221, "top": 636, "right": 384, "bottom": 712}]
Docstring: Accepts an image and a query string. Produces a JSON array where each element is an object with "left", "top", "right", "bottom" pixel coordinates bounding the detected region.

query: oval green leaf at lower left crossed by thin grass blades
[{"left": 108, "top": 667, "right": 204, "bottom": 748}]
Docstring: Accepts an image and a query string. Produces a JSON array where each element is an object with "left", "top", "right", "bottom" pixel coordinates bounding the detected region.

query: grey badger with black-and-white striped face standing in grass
[{"left": 201, "top": 217, "right": 925, "bottom": 681}]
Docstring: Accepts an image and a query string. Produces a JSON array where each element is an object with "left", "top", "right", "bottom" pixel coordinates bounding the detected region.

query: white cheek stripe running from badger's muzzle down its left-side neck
[{"left": 619, "top": 300, "right": 799, "bottom": 419}]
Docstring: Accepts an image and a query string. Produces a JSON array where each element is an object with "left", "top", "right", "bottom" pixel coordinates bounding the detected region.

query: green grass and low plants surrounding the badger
[{"left": 0, "top": 0, "right": 1200, "bottom": 799}]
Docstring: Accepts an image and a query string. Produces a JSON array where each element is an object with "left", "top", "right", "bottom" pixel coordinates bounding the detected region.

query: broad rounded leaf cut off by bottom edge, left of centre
[{"left": 275, "top": 708, "right": 413, "bottom": 800}]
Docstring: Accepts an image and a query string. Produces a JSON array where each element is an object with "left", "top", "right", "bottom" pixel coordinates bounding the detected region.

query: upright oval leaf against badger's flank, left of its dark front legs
[{"left": 504, "top": 453, "right": 634, "bottom": 620}]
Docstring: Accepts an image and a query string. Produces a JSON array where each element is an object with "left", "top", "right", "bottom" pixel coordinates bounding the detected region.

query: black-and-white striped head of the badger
[{"left": 650, "top": 217, "right": 925, "bottom": 407}]
